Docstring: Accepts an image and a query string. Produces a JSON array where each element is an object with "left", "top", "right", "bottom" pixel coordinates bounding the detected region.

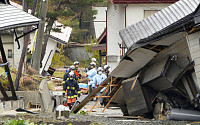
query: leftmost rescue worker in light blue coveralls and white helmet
[{"left": 87, "top": 62, "right": 97, "bottom": 93}]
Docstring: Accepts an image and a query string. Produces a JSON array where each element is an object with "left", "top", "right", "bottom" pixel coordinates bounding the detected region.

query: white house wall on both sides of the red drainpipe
[{"left": 107, "top": 3, "right": 170, "bottom": 71}]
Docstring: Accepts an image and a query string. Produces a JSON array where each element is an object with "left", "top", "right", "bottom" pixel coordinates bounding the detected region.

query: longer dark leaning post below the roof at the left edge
[{"left": 0, "top": 36, "right": 17, "bottom": 100}]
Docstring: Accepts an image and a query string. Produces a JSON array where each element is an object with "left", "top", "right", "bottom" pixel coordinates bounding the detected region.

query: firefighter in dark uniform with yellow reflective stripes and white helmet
[{"left": 63, "top": 72, "right": 81, "bottom": 110}]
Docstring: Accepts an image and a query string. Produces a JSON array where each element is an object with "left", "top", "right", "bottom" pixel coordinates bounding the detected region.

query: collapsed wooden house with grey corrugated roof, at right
[{"left": 75, "top": 0, "right": 200, "bottom": 120}]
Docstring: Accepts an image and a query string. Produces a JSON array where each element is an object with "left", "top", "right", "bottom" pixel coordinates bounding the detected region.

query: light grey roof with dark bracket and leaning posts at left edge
[{"left": 0, "top": 0, "right": 40, "bottom": 100}]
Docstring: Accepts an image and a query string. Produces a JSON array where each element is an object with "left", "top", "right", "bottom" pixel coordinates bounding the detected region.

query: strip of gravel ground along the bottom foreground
[{"left": 0, "top": 113, "right": 198, "bottom": 125}]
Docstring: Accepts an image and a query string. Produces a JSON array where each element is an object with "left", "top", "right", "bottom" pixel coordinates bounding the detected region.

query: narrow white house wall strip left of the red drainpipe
[{"left": 107, "top": 3, "right": 124, "bottom": 71}]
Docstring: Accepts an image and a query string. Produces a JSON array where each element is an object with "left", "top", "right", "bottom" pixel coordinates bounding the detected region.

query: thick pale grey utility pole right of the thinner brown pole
[{"left": 33, "top": 0, "right": 48, "bottom": 72}]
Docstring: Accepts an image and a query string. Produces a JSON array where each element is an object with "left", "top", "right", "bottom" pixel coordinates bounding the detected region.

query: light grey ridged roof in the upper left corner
[{"left": 0, "top": 3, "right": 40, "bottom": 30}]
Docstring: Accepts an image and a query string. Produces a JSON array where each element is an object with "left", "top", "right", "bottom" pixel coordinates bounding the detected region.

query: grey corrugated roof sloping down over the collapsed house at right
[{"left": 120, "top": 0, "right": 200, "bottom": 48}]
